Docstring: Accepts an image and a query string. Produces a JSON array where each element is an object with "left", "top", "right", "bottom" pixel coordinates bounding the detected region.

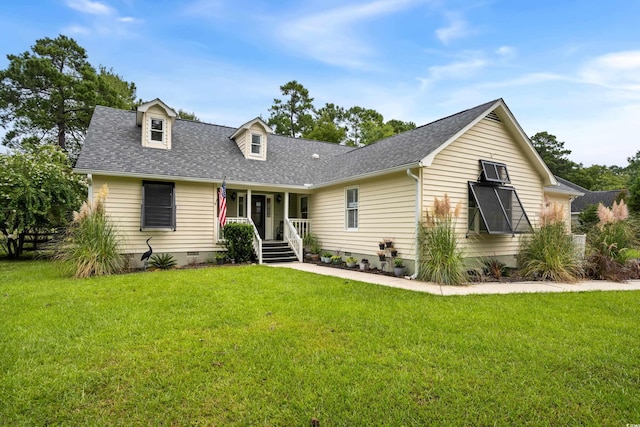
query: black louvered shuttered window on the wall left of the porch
[{"left": 140, "top": 181, "right": 176, "bottom": 231}]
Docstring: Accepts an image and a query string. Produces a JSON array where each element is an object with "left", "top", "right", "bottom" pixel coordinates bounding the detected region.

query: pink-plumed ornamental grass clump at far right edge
[{"left": 587, "top": 200, "right": 637, "bottom": 281}]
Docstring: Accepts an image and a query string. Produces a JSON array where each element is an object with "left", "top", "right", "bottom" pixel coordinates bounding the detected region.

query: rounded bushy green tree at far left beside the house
[{"left": 0, "top": 146, "right": 86, "bottom": 258}]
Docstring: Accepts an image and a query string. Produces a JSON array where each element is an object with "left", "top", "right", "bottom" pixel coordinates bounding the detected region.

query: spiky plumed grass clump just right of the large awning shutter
[{"left": 517, "top": 201, "right": 582, "bottom": 283}]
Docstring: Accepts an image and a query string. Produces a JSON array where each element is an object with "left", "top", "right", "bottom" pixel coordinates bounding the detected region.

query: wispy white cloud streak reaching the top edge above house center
[{"left": 277, "top": 0, "right": 414, "bottom": 68}]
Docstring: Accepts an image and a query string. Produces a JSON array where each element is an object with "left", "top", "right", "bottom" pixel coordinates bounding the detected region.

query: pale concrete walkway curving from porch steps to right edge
[{"left": 268, "top": 262, "right": 640, "bottom": 296}]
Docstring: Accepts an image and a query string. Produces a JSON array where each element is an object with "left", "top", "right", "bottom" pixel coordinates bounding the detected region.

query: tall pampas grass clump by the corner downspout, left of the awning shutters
[{"left": 418, "top": 194, "right": 467, "bottom": 285}]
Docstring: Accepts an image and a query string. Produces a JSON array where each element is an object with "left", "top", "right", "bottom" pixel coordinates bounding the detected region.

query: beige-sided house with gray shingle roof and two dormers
[{"left": 75, "top": 99, "right": 575, "bottom": 271}]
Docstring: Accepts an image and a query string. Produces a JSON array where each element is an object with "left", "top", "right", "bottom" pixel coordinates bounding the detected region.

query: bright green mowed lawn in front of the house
[{"left": 0, "top": 261, "right": 640, "bottom": 426}]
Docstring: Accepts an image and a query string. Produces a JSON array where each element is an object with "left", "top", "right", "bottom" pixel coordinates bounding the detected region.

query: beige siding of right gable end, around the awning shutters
[{"left": 423, "top": 118, "right": 543, "bottom": 257}]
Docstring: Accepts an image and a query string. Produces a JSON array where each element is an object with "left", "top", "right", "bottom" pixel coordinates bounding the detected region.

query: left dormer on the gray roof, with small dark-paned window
[{"left": 136, "top": 98, "right": 178, "bottom": 150}]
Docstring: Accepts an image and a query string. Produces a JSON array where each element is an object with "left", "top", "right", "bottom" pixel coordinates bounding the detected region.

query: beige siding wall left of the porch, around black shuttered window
[{"left": 93, "top": 175, "right": 217, "bottom": 253}]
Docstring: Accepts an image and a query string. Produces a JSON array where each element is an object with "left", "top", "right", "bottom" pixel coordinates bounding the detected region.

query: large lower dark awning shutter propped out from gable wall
[{"left": 469, "top": 182, "right": 531, "bottom": 234}]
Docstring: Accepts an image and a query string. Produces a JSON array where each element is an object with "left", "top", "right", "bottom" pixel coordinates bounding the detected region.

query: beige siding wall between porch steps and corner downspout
[{"left": 309, "top": 173, "right": 416, "bottom": 261}]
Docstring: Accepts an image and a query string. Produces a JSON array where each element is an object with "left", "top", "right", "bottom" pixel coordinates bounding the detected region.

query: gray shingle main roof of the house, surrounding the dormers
[{"left": 76, "top": 100, "right": 497, "bottom": 186}]
